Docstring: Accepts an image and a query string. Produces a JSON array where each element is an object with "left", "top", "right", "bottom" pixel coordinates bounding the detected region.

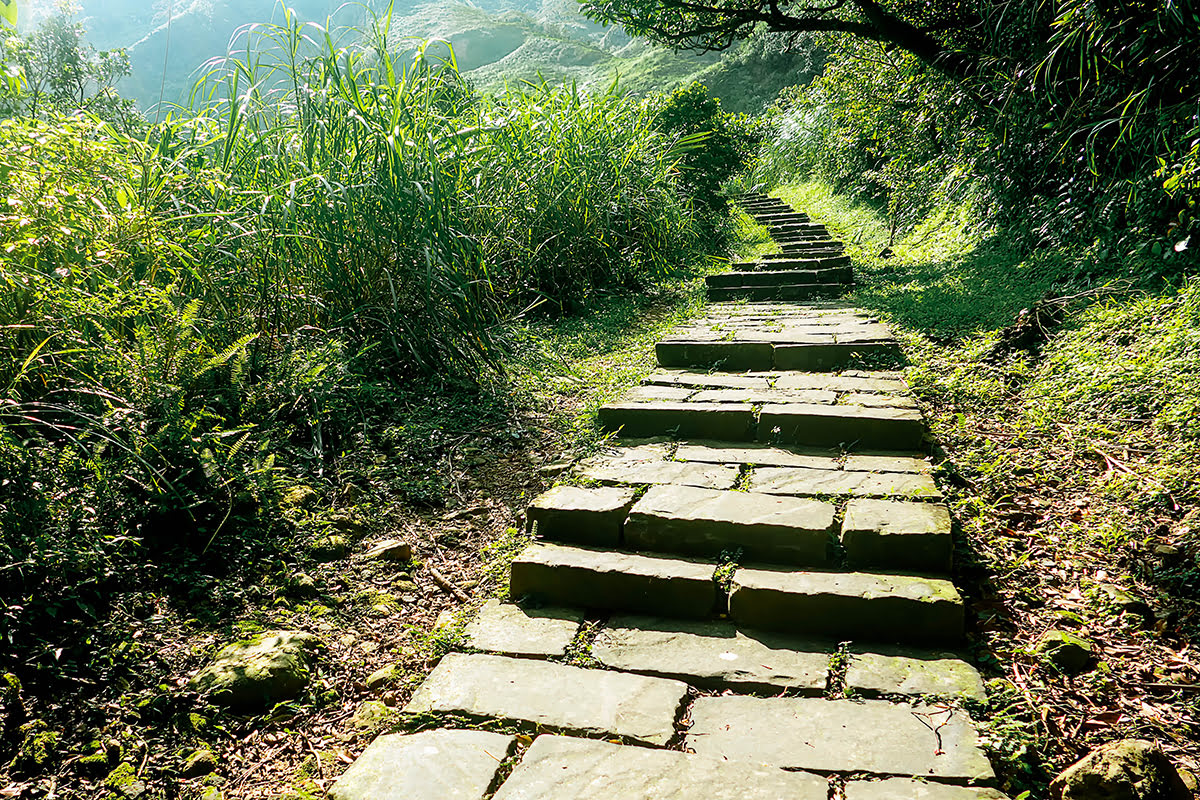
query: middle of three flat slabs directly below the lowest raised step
[{"left": 592, "top": 616, "right": 832, "bottom": 694}]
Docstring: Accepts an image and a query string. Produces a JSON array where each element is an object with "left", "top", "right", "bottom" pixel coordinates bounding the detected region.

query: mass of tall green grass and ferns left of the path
[{"left": 0, "top": 6, "right": 729, "bottom": 705}]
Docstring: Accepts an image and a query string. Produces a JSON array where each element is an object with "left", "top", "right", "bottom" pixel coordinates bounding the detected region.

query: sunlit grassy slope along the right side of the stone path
[{"left": 776, "top": 184, "right": 1200, "bottom": 796}]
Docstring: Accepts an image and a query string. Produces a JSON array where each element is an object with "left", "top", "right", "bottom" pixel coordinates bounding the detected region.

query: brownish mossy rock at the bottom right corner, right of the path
[{"left": 1050, "top": 739, "right": 1192, "bottom": 800}]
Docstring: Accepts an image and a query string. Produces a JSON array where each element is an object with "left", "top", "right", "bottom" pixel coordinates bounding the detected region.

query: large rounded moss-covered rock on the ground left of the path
[{"left": 188, "top": 631, "right": 319, "bottom": 710}]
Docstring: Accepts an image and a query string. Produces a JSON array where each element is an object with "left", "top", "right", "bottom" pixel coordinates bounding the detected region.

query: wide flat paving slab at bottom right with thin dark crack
[{"left": 685, "top": 696, "right": 992, "bottom": 781}]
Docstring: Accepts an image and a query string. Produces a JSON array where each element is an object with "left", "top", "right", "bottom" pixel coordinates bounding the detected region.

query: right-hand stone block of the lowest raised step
[{"left": 730, "top": 569, "right": 964, "bottom": 643}]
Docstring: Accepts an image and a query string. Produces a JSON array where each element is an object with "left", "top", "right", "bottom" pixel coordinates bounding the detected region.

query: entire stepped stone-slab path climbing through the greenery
[{"left": 330, "top": 196, "right": 1002, "bottom": 800}]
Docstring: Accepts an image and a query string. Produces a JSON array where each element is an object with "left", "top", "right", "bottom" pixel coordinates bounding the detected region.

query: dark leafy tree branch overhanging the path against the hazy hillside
[{"left": 583, "top": 0, "right": 982, "bottom": 79}]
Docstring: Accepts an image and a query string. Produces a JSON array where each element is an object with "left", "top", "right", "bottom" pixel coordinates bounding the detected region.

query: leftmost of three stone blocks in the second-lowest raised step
[{"left": 527, "top": 486, "right": 635, "bottom": 547}]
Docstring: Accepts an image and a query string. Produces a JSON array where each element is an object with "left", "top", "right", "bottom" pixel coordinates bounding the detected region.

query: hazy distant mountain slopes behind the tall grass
[{"left": 22, "top": 0, "right": 806, "bottom": 112}]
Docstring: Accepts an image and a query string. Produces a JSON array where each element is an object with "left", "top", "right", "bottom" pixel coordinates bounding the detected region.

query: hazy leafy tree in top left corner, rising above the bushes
[{"left": 0, "top": 6, "right": 137, "bottom": 125}]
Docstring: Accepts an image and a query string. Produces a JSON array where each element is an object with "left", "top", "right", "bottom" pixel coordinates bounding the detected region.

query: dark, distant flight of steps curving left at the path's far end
[{"left": 706, "top": 194, "right": 854, "bottom": 301}]
